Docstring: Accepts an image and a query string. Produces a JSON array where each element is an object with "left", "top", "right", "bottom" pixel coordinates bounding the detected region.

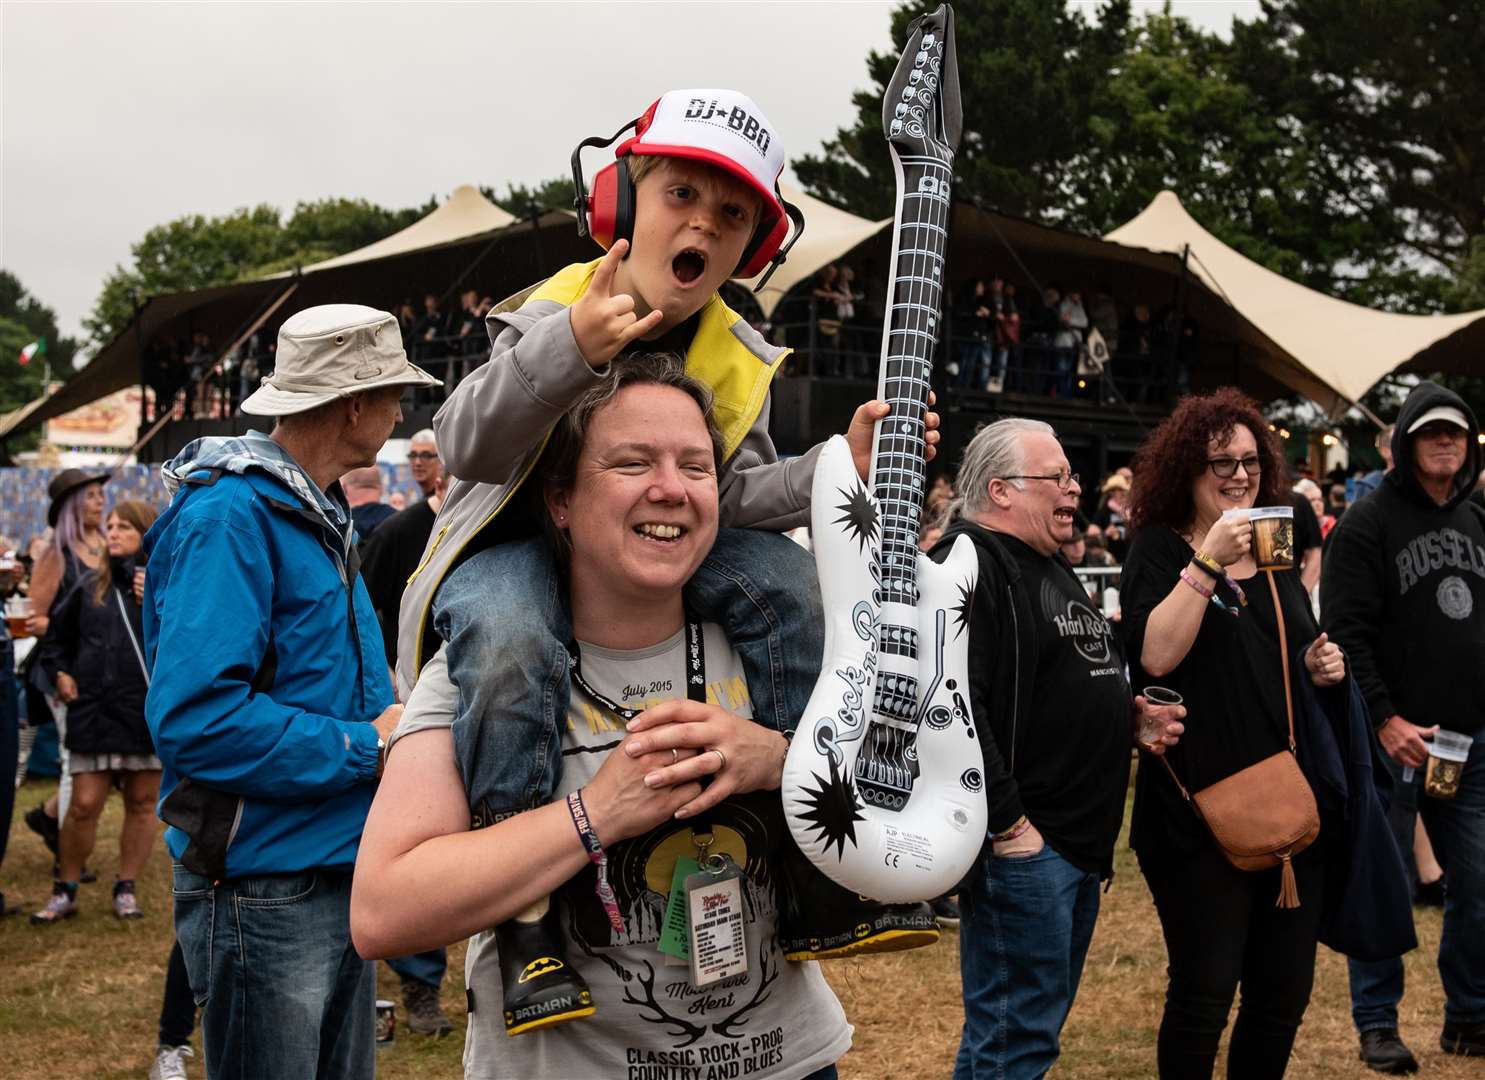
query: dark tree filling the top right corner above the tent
[{"left": 1233, "top": 0, "right": 1485, "bottom": 310}]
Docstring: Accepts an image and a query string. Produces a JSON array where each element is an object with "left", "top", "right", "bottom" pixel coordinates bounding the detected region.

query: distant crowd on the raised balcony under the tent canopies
[{"left": 144, "top": 263, "right": 1200, "bottom": 419}]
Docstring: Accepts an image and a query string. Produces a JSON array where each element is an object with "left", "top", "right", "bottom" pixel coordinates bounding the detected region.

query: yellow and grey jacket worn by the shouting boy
[{"left": 396, "top": 260, "right": 820, "bottom": 701}]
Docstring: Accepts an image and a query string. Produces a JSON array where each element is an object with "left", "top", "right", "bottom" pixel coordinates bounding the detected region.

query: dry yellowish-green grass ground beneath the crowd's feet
[{"left": 0, "top": 781, "right": 1485, "bottom": 1080}]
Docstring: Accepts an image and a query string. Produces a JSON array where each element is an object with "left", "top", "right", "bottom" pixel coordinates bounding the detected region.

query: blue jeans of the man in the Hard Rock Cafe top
[{"left": 953, "top": 845, "right": 1099, "bottom": 1080}]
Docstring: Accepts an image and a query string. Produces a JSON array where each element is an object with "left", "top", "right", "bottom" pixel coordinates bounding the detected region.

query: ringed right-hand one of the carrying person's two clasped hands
[{"left": 624, "top": 701, "right": 789, "bottom": 819}]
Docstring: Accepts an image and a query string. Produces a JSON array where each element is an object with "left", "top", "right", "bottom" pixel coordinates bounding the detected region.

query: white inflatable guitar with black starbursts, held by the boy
[{"left": 783, "top": 4, "right": 986, "bottom": 902}]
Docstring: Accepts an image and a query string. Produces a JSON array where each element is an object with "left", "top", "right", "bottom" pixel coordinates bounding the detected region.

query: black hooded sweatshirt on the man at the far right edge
[{"left": 1320, "top": 383, "right": 1485, "bottom": 734}]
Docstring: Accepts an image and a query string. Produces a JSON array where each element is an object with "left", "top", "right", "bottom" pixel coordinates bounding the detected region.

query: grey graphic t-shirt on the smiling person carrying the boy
[{"left": 396, "top": 624, "right": 851, "bottom": 1080}]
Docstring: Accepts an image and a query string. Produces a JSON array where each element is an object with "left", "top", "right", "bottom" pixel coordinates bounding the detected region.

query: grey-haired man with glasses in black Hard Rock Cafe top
[{"left": 933, "top": 419, "right": 1182, "bottom": 1080}]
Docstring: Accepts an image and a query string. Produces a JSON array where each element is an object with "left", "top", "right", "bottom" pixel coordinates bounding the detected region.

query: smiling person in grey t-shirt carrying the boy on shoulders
[{"left": 352, "top": 354, "right": 849, "bottom": 1079}]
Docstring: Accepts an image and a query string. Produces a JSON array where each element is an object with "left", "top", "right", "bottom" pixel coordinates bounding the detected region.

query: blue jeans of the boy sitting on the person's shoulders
[{"left": 434, "top": 529, "right": 824, "bottom": 824}]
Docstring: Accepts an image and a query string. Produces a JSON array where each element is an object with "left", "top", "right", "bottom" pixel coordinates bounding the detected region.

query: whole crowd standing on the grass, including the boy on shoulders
[{"left": 0, "top": 84, "right": 1485, "bottom": 1080}]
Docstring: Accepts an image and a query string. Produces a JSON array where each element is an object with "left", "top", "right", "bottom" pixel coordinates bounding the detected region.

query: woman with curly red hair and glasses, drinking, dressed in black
[{"left": 1120, "top": 388, "right": 1344, "bottom": 1080}]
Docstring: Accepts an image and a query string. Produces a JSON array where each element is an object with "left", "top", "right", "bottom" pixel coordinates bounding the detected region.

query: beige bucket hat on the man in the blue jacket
[{"left": 242, "top": 303, "right": 443, "bottom": 416}]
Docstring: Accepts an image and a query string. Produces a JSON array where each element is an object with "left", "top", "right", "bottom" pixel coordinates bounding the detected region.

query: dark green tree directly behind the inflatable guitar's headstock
[{"left": 793, "top": 0, "right": 1130, "bottom": 218}]
